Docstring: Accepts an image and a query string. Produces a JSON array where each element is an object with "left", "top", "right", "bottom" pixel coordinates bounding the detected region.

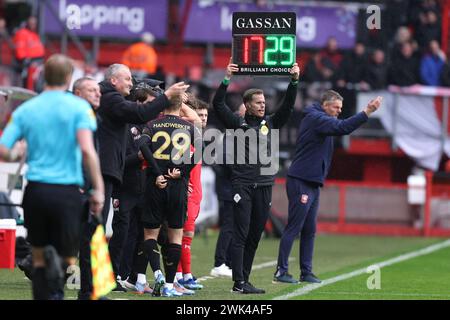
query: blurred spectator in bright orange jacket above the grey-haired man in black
[{"left": 122, "top": 32, "right": 158, "bottom": 78}]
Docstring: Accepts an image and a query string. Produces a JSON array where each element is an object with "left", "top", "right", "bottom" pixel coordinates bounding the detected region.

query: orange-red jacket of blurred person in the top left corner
[{"left": 13, "top": 28, "right": 45, "bottom": 60}]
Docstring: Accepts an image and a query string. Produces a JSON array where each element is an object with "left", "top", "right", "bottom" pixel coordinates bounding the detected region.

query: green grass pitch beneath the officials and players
[{"left": 0, "top": 230, "right": 450, "bottom": 300}]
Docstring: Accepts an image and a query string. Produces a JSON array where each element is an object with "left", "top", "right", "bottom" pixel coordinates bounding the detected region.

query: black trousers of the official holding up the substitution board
[{"left": 232, "top": 185, "right": 272, "bottom": 281}]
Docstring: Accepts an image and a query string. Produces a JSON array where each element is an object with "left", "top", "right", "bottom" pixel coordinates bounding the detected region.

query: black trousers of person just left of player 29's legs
[{"left": 109, "top": 192, "right": 143, "bottom": 280}]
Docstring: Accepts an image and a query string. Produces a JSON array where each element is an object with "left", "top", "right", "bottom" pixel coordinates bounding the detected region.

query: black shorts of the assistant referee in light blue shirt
[{"left": 22, "top": 181, "right": 83, "bottom": 257}]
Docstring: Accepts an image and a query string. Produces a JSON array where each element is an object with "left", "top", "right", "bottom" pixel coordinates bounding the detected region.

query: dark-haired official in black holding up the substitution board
[{"left": 213, "top": 63, "right": 300, "bottom": 293}]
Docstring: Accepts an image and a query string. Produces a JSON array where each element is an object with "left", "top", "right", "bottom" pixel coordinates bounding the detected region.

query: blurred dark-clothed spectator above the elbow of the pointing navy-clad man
[{"left": 337, "top": 42, "right": 367, "bottom": 87}]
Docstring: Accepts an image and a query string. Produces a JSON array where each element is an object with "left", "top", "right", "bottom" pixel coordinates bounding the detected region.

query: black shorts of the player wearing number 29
[{"left": 142, "top": 179, "right": 188, "bottom": 229}]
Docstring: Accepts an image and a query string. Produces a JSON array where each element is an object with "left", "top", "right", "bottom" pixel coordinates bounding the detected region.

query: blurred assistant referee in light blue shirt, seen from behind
[{"left": 0, "top": 54, "right": 104, "bottom": 299}]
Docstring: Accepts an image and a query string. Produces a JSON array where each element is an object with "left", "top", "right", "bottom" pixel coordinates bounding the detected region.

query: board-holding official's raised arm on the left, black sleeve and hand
[{"left": 213, "top": 58, "right": 242, "bottom": 129}]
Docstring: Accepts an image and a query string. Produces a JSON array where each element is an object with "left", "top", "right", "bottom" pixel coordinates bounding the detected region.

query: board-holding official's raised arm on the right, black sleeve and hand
[{"left": 270, "top": 63, "right": 300, "bottom": 129}]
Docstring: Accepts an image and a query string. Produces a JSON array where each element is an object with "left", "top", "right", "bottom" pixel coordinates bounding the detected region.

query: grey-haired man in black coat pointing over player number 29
[{"left": 97, "top": 64, "right": 189, "bottom": 290}]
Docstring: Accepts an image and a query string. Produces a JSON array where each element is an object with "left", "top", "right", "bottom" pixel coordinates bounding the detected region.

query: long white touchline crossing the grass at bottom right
[{"left": 273, "top": 240, "right": 450, "bottom": 300}]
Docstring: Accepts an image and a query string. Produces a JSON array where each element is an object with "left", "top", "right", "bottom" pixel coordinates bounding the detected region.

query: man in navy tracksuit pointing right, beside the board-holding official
[{"left": 274, "top": 90, "right": 382, "bottom": 283}]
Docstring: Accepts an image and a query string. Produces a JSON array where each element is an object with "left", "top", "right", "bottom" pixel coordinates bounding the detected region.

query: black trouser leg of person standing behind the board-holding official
[{"left": 214, "top": 200, "right": 234, "bottom": 267}]
